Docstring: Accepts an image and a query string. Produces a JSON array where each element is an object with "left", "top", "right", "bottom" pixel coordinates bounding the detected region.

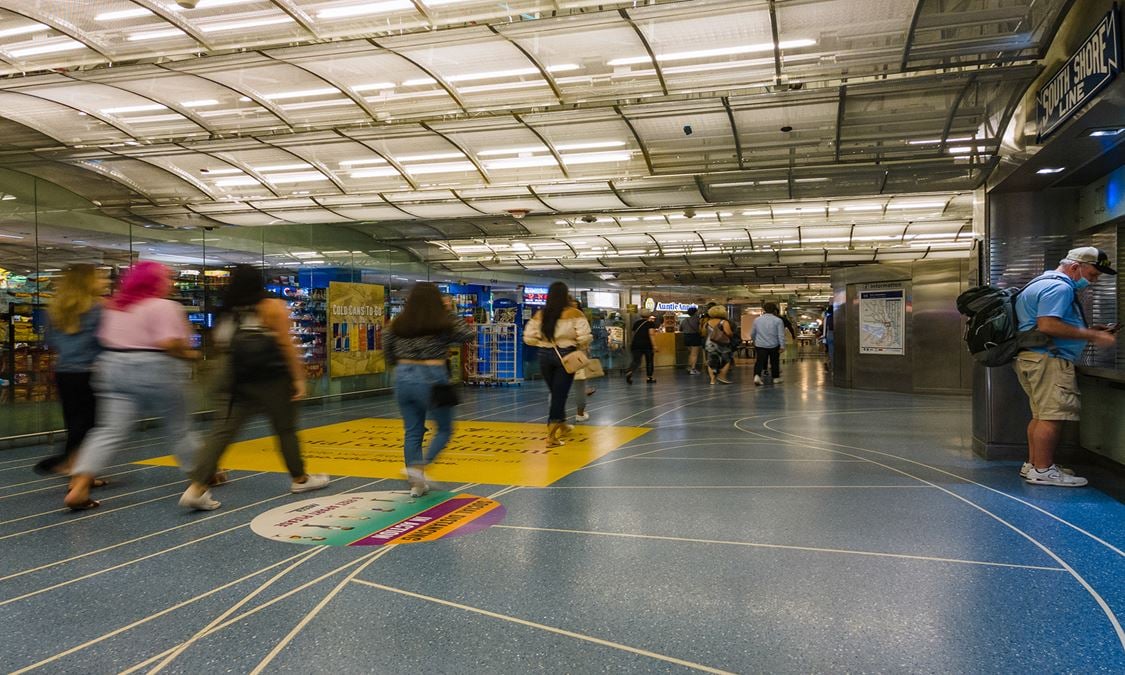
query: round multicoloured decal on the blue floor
[{"left": 250, "top": 492, "right": 505, "bottom": 546}]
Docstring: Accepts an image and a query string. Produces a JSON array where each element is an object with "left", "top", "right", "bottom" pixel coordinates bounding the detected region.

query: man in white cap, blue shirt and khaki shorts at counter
[{"left": 1015, "top": 246, "right": 1117, "bottom": 487}]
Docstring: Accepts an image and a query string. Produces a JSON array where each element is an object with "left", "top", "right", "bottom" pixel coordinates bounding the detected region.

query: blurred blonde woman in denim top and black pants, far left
[{"left": 35, "top": 263, "right": 109, "bottom": 479}]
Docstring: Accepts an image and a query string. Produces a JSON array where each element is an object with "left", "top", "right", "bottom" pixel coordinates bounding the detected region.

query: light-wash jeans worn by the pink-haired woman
[{"left": 72, "top": 351, "right": 199, "bottom": 474}]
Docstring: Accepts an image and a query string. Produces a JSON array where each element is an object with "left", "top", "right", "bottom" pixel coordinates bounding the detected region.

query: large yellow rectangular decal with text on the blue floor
[{"left": 138, "top": 417, "right": 649, "bottom": 487}]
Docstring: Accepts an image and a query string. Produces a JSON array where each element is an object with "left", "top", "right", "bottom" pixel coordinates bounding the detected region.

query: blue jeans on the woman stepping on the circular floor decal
[{"left": 395, "top": 363, "right": 453, "bottom": 467}]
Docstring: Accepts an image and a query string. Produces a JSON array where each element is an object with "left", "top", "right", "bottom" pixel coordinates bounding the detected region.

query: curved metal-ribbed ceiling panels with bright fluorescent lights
[{"left": 0, "top": 0, "right": 1068, "bottom": 286}]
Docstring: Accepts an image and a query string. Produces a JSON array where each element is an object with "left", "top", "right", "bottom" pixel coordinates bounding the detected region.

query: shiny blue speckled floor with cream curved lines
[{"left": 0, "top": 361, "right": 1125, "bottom": 674}]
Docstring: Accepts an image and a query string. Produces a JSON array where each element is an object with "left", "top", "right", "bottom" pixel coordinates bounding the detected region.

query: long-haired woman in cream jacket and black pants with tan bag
[{"left": 523, "top": 281, "right": 594, "bottom": 448}]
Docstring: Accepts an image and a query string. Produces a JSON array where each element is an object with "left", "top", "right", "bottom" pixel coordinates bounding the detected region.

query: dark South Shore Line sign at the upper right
[{"left": 1035, "top": 7, "right": 1122, "bottom": 142}]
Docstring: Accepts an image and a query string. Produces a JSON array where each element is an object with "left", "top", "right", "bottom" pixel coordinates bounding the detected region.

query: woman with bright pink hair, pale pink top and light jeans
[{"left": 63, "top": 261, "right": 199, "bottom": 511}]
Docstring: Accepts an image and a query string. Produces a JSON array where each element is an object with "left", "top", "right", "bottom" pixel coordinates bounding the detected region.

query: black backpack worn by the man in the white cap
[{"left": 957, "top": 278, "right": 1053, "bottom": 368}]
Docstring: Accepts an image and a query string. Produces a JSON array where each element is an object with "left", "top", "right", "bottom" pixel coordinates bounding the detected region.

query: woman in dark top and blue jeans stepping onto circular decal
[{"left": 384, "top": 282, "right": 475, "bottom": 497}]
